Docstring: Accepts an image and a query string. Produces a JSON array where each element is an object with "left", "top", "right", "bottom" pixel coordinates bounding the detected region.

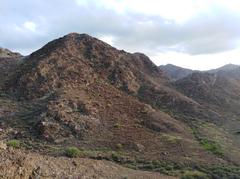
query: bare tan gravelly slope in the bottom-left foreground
[{"left": 0, "top": 150, "right": 175, "bottom": 179}]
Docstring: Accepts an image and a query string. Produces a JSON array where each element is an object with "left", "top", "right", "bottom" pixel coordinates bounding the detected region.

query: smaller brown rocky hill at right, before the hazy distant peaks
[{"left": 175, "top": 73, "right": 240, "bottom": 114}]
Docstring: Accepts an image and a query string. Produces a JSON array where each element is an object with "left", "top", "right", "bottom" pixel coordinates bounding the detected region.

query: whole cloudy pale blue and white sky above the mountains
[{"left": 0, "top": 0, "right": 240, "bottom": 70}]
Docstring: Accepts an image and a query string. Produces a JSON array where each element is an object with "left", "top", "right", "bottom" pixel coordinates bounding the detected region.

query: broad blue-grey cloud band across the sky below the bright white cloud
[{"left": 0, "top": 0, "right": 240, "bottom": 55}]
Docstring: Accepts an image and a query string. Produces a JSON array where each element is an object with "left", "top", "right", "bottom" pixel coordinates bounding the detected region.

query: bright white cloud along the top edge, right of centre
[{"left": 79, "top": 0, "right": 240, "bottom": 24}]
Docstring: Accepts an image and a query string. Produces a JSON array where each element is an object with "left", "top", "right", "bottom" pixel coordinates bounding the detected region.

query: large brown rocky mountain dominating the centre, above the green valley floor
[{"left": 5, "top": 33, "right": 204, "bottom": 159}]
